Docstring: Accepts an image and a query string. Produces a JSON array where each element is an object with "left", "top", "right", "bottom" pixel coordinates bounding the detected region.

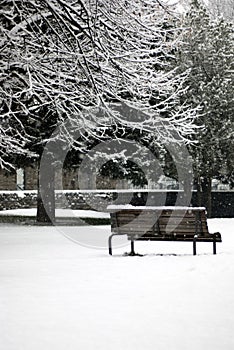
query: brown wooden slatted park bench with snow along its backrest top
[{"left": 107, "top": 205, "right": 222, "bottom": 255}]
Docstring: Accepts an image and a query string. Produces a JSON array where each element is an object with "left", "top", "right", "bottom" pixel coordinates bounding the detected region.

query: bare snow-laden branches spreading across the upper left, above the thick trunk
[{"left": 0, "top": 0, "right": 197, "bottom": 221}]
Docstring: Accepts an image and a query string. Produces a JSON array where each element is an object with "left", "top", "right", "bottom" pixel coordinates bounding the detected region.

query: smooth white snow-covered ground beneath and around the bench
[{"left": 0, "top": 219, "right": 234, "bottom": 350}]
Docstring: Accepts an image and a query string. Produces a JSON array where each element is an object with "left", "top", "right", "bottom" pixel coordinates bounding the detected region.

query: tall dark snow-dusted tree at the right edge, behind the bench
[{"left": 175, "top": 1, "right": 234, "bottom": 213}]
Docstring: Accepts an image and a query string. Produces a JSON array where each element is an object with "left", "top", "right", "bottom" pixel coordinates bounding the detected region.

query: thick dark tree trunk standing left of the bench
[{"left": 36, "top": 159, "right": 55, "bottom": 224}]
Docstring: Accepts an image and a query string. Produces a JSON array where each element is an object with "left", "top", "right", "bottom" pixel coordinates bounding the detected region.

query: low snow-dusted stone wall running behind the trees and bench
[{"left": 0, "top": 190, "right": 234, "bottom": 218}]
